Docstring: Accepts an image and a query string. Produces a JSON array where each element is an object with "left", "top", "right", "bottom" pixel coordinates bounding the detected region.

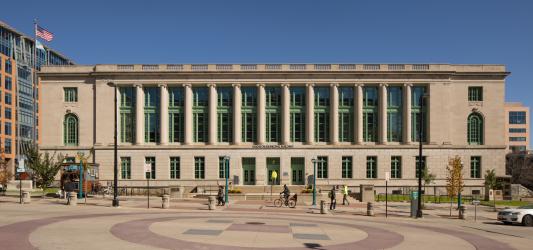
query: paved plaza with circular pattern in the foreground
[{"left": 0, "top": 197, "right": 533, "bottom": 250}]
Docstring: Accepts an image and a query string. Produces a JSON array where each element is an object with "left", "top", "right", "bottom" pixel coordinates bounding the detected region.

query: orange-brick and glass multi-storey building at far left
[{"left": 0, "top": 21, "right": 72, "bottom": 171}]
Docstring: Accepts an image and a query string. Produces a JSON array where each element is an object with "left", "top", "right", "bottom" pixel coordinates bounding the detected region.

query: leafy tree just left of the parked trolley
[{"left": 25, "top": 145, "right": 64, "bottom": 198}]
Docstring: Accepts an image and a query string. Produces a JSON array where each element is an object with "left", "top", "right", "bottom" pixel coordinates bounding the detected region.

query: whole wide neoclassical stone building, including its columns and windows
[{"left": 39, "top": 64, "right": 508, "bottom": 193}]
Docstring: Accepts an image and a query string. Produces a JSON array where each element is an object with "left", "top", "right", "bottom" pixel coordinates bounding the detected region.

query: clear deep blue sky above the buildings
[{"left": 4, "top": 0, "right": 533, "bottom": 147}]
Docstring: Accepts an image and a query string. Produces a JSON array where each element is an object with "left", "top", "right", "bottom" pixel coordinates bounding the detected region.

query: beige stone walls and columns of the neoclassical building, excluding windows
[{"left": 40, "top": 64, "right": 508, "bottom": 192}]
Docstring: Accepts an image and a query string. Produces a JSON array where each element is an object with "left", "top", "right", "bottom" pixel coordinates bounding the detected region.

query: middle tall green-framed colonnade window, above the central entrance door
[{"left": 265, "top": 87, "right": 281, "bottom": 142}]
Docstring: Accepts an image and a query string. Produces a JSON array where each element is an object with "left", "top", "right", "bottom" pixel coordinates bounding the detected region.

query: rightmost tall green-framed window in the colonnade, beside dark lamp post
[{"left": 411, "top": 86, "right": 428, "bottom": 142}]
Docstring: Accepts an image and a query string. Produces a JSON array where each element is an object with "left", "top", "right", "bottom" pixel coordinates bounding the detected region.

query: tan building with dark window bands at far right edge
[{"left": 505, "top": 102, "right": 530, "bottom": 152}]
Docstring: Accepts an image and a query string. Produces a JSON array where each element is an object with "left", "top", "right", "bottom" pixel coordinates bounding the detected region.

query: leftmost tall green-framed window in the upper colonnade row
[{"left": 119, "top": 87, "right": 135, "bottom": 143}]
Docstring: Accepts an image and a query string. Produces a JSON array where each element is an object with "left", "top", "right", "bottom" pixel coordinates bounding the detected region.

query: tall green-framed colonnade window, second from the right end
[{"left": 387, "top": 86, "right": 403, "bottom": 142}]
